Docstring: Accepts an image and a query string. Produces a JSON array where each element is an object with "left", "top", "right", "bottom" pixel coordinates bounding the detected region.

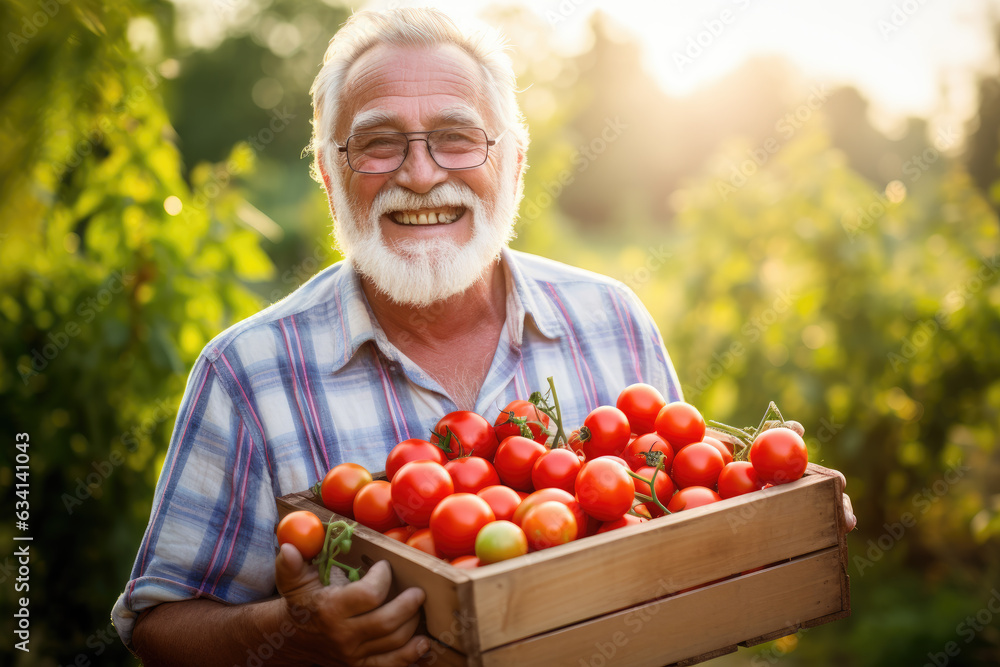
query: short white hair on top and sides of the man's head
[{"left": 309, "top": 7, "right": 528, "bottom": 185}]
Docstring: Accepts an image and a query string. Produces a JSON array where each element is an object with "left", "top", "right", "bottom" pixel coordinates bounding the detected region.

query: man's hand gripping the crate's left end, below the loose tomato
[{"left": 274, "top": 544, "right": 430, "bottom": 667}]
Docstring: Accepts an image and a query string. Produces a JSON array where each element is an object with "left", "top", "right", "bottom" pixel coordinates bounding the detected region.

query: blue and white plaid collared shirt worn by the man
[{"left": 112, "top": 250, "right": 681, "bottom": 646}]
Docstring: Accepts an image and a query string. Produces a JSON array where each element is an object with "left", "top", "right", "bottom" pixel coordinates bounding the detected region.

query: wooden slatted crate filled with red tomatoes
[{"left": 278, "top": 464, "right": 850, "bottom": 667}]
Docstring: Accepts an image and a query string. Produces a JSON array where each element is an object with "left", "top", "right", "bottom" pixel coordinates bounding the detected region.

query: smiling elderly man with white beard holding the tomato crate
[{"left": 113, "top": 10, "right": 852, "bottom": 667}]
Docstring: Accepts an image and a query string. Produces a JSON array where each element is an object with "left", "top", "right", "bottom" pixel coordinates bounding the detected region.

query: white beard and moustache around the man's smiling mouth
[{"left": 330, "top": 151, "right": 520, "bottom": 307}]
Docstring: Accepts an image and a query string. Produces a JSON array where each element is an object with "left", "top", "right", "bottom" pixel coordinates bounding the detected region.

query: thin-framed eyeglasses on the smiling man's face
[{"left": 337, "top": 127, "right": 506, "bottom": 174}]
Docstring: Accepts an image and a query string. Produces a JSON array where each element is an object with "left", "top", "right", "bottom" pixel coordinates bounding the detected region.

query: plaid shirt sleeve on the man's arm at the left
[{"left": 111, "top": 355, "right": 277, "bottom": 650}]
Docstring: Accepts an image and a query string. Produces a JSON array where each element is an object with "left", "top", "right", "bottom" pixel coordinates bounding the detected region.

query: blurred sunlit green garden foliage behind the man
[{"left": 0, "top": 0, "right": 1000, "bottom": 666}]
